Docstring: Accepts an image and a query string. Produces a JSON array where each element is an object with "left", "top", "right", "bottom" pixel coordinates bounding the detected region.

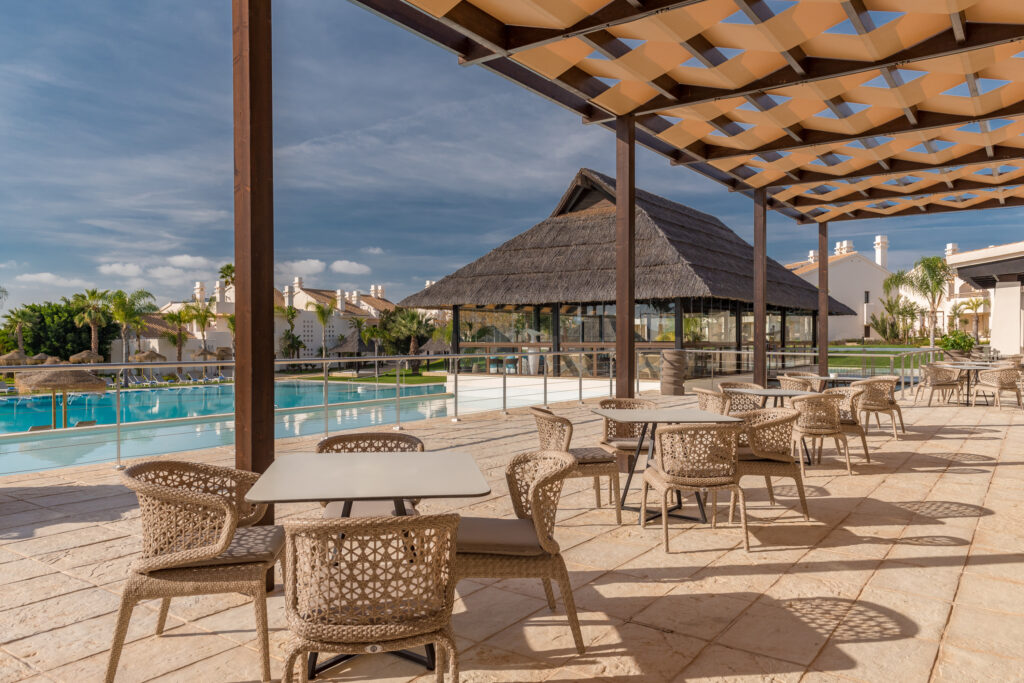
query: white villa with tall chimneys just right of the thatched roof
[{"left": 785, "top": 234, "right": 890, "bottom": 341}]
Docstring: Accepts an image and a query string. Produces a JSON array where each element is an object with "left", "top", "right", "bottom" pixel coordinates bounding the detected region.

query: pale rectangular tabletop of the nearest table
[{"left": 246, "top": 453, "right": 490, "bottom": 503}]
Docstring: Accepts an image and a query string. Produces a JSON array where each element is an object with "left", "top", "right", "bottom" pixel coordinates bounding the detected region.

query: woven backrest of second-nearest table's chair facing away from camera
[{"left": 654, "top": 423, "right": 743, "bottom": 485}]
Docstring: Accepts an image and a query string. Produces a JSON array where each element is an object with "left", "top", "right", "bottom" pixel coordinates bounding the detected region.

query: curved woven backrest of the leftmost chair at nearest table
[{"left": 121, "top": 460, "right": 266, "bottom": 572}]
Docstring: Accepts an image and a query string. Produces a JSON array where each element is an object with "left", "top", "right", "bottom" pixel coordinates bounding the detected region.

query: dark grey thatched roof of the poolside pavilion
[{"left": 400, "top": 169, "right": 854, "bottom": 315}]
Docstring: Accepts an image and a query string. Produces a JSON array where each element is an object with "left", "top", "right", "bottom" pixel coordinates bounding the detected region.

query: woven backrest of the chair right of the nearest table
[{"left": 505, "top": 451, "right": 577, "bottom": 555}]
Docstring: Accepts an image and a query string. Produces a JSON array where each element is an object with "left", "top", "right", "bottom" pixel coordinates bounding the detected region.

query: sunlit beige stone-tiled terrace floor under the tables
[{"left": 0, "top": 389, "right": 1024, "bottom": 683}]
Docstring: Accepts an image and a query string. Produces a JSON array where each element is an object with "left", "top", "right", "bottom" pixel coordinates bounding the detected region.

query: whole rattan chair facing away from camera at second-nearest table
[{"left": 640, "top": 423, "right": 751, "bottom": 552}]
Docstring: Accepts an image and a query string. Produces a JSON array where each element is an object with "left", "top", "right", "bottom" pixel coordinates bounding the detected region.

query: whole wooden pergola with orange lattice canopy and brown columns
[{"left": 232, "top": 0, "right": 1024, "bottom": 481}]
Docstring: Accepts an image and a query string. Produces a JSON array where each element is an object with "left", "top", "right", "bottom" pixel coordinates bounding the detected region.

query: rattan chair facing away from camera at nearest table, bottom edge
[{"left": 283, "top": 513, "right": 459, "bottom": 683}]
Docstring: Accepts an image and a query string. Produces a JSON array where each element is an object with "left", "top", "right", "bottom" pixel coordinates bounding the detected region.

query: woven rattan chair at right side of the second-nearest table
[{"left": 729, "top": 408, "right": 810, "bottom": 522}]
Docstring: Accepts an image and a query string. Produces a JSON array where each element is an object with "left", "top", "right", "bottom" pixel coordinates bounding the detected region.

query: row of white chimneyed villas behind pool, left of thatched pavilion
[{"left": 111, "top": 276, "right": 395, "bottom": 362}]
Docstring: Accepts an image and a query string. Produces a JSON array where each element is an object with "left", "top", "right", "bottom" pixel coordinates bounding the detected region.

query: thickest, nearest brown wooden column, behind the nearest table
[{"left": 231, "top": 0, "right": 273, "bottom": 485}]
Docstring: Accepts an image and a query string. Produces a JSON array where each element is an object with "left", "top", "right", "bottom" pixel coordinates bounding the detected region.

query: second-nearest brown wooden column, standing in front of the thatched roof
[{"left": 615, "top": 116, "right": 637, "bottom": 398}]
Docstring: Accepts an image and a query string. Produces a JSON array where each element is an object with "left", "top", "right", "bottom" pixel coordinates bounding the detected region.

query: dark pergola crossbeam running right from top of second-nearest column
[{"left": 591, "top": 23, "right": 1024, "bottom": 123}]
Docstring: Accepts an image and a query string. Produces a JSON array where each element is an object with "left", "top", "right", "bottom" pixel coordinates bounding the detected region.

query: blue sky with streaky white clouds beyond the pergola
[{"left": 0, "top": 0, "right": 1022, "bottom": 307}]
